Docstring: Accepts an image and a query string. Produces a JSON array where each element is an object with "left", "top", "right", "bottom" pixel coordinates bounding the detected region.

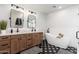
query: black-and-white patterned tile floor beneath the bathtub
[{"left": 38, "top": 40, "right": 77, "bottom": 54}]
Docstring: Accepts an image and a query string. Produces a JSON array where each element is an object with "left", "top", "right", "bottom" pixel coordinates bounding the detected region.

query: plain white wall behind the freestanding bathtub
[{"left": 47, "top": 6, "right": 79, "bottom": 48}]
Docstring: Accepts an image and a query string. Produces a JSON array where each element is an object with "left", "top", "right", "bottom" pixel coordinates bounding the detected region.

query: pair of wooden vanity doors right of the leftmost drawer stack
[{"left": 11, "top": 34, "right": 26, "bottom": 54}]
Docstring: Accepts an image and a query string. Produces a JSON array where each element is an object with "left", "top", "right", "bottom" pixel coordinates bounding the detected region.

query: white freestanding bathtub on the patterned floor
[{"left": 45, "top": 33, "right": 70, "bottom": 49}]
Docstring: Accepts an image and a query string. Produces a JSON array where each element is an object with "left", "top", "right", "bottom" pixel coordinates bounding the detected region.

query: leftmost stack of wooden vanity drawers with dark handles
[{"left": 0, "top": 36, "right": 10, "bottom": 54}]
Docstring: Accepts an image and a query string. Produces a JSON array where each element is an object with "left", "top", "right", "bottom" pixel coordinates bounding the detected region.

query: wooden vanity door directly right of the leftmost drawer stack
[{"left": 11, "top": 36, "right": 19, "bottom": 54}]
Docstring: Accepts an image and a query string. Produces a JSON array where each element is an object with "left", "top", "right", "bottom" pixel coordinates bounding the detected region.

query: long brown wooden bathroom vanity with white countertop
[{"left": 0, "top": 32, "right": 43, "bottom": 54}]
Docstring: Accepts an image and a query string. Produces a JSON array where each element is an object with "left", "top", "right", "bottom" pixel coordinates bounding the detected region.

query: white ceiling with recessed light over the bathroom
[{"left": 19, "top": 4, "right": 74, "bottom": 13}]
